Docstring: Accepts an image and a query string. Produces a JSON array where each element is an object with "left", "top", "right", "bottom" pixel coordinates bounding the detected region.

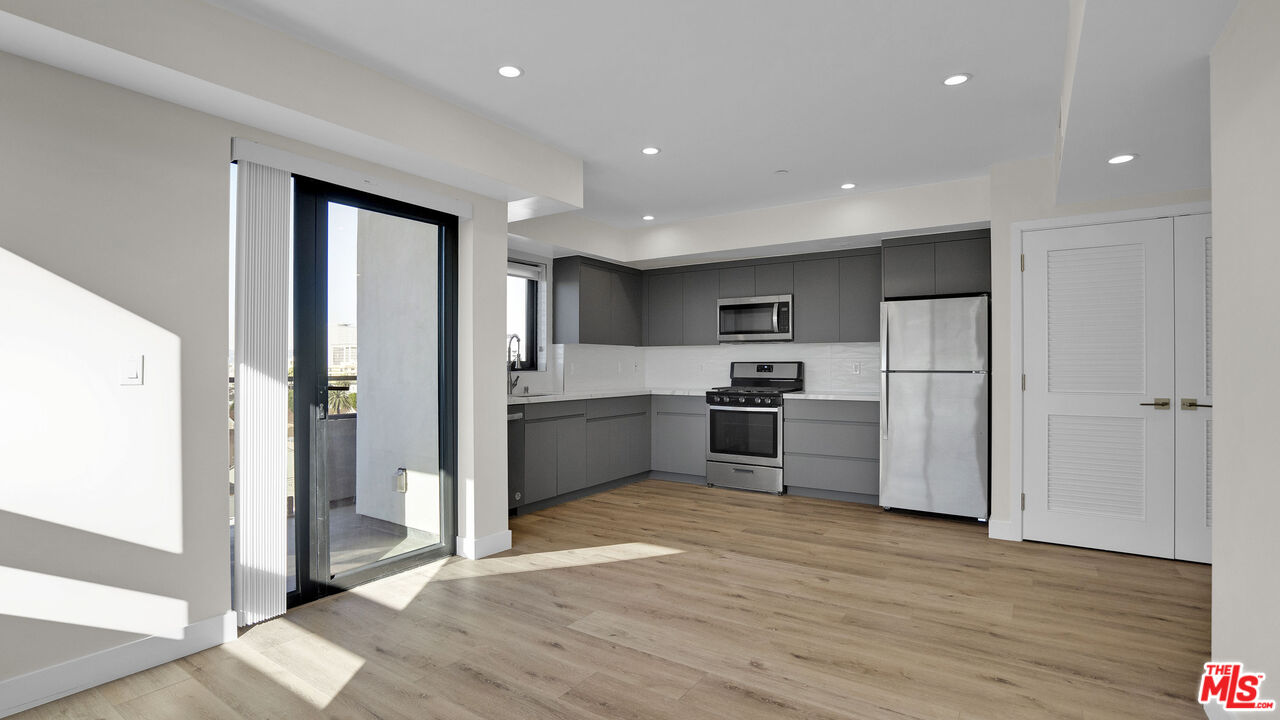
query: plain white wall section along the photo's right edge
[{"left": 1211, "top": 0, "right": 1280, "bottom": 700}]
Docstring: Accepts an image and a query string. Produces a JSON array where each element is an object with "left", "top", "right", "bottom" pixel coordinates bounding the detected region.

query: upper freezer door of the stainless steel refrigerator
[{"left": 881, "top": 296, "right": 989, "bottom": 372}]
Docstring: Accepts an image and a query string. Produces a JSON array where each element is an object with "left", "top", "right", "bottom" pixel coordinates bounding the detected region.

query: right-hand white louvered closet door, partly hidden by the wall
[{"left": 1174, "top": 214, "right": 1213, "bottom": 562}]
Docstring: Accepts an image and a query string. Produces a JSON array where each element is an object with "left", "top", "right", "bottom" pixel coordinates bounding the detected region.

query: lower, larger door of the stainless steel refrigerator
[{"left": 879, "top": 373, "right": 991, "bottom": 519}]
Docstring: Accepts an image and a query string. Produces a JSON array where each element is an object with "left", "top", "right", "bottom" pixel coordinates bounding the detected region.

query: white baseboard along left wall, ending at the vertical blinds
[{"left": 0, "top": 612, "right": 237, "bottom": 717}]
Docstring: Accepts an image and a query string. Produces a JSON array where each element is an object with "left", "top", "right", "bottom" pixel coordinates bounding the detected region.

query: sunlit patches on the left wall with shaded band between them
[{"left": 0, "top": 243, "right": 188, "bottom": 648}]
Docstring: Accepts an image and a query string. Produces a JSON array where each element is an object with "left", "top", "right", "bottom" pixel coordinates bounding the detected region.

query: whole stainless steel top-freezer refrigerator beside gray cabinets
[{"left": 879, "top": 297, "right": 991, "bottom": 520}]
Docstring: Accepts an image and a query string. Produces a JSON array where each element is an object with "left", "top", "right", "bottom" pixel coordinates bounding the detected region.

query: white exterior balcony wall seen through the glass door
[{"left": 355, "top": 210, "right": 440, "bottom": 534}]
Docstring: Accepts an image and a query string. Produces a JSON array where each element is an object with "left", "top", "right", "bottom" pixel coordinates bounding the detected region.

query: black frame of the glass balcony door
[{"left": 288, "top": 174, "right": 458, "bottom": 607}]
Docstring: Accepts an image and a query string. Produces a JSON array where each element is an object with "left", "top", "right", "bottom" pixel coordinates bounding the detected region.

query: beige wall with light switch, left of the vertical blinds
[{"left": 0, "top": 50, "right": 230, "bottom": 679}]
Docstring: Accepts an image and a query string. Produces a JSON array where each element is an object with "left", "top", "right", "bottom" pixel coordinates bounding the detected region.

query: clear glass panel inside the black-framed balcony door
[{"left": 324, "top": 202, "right": 442, "bottom": 577}]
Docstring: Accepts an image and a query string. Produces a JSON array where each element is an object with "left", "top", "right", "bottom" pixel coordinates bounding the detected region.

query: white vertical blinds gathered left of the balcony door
[{"left": 234, "top": 160, "right": 291, "bottom": 626}]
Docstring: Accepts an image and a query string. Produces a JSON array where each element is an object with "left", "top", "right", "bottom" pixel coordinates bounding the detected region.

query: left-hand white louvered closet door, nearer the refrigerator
[{"left": 1023, "top": 218, "right": 1178, "bottom": 557}]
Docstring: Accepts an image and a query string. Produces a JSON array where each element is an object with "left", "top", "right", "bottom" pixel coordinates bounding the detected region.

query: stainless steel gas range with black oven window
[{"left": 707, "top": 363, "right": 804, "bottom": 495}]
